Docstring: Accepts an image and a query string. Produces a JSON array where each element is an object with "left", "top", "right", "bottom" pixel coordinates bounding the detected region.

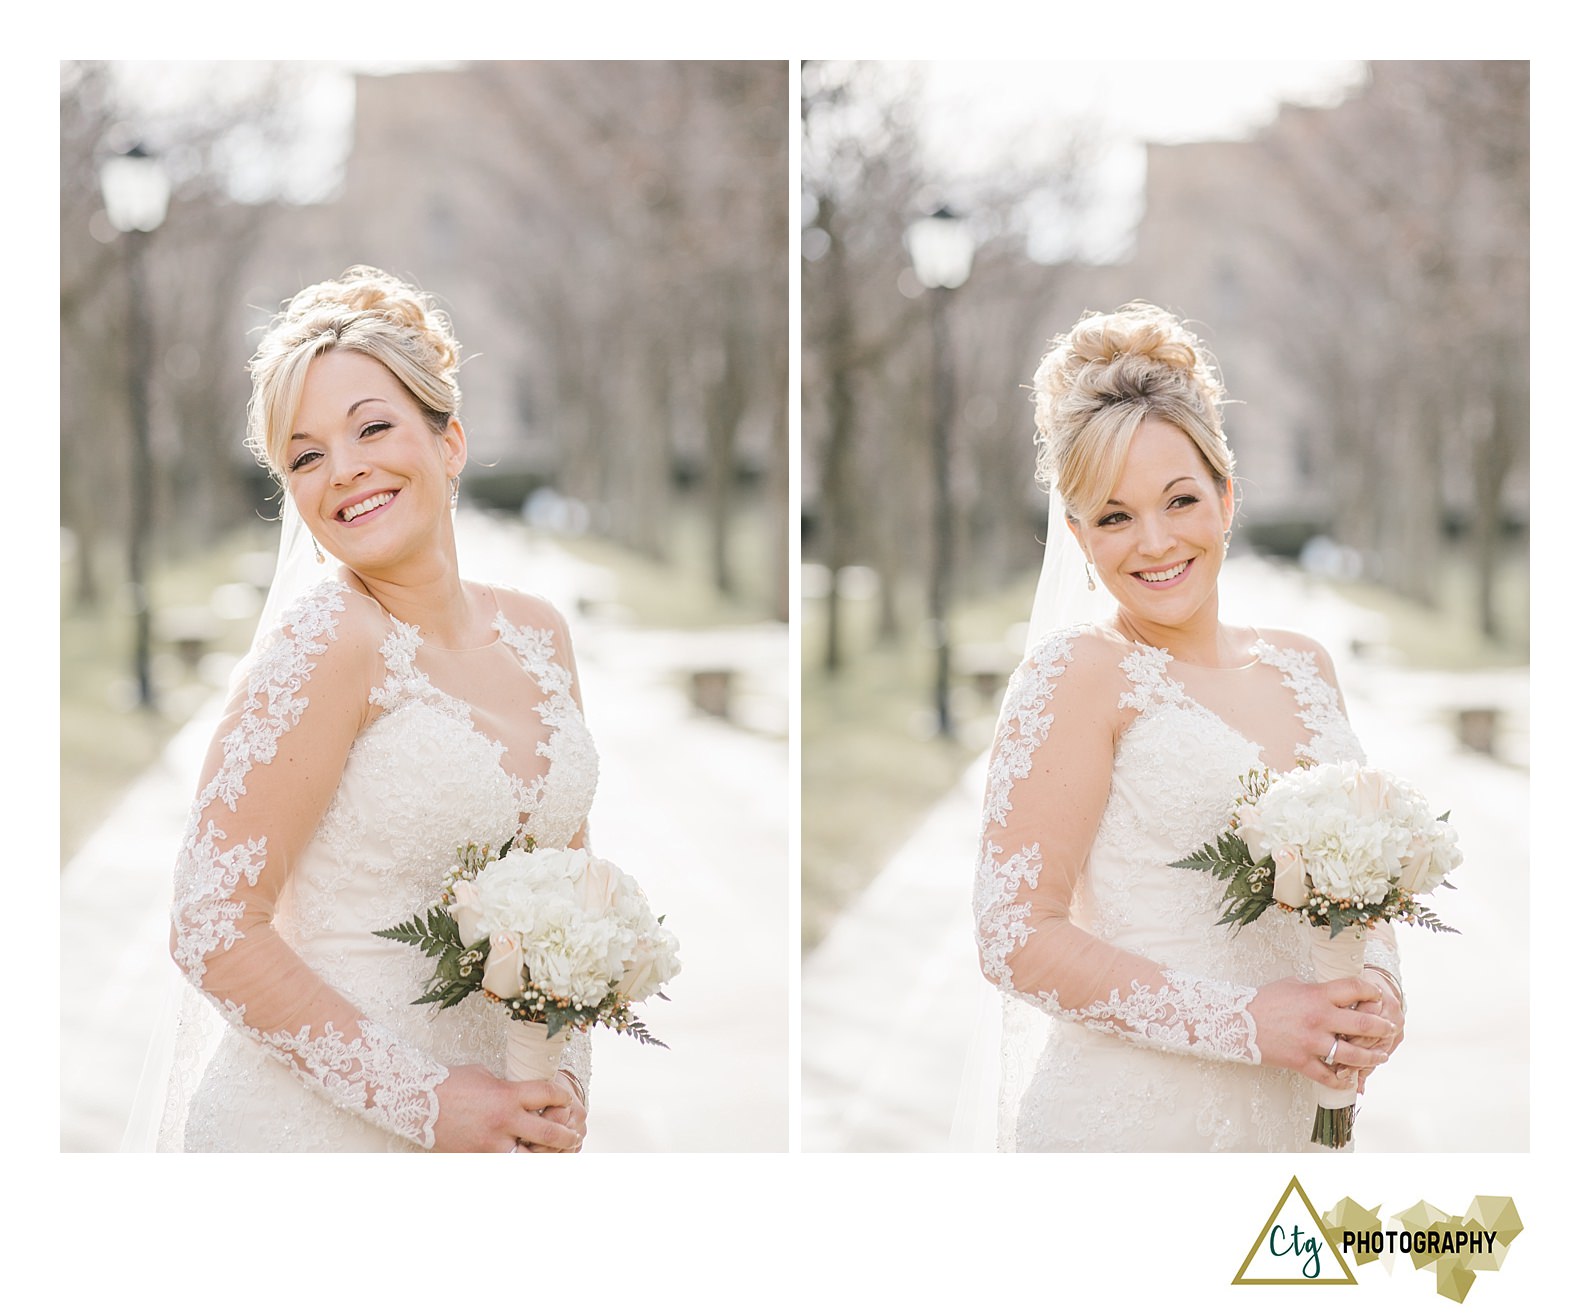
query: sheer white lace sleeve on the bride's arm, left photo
[{"left": 172, "top": 582, "right": 448, "bottom": 1148}]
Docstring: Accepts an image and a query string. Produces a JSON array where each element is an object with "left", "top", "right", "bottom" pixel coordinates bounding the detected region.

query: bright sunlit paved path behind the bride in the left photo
[{"left": 60, "top": 518, "right": 790, "bottom": 1151}]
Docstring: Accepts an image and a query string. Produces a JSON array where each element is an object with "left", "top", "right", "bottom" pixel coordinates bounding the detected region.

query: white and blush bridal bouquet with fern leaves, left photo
[{"left": 375, "top": 841, "right": 679, "bottom": 1081}]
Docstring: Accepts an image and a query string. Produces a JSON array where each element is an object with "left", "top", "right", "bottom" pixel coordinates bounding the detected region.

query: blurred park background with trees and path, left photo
[{"left": 60, "top": 62, "right": 789, "bottom": 1149}]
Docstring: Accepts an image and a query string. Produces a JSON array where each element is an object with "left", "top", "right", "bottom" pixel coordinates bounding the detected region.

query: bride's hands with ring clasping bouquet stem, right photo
[{"left": 1248, "top": 976, "right": 1396, "bottom": 1089}]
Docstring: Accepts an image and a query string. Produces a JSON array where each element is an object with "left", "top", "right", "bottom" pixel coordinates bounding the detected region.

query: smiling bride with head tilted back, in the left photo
[{"left": 161, "top": 265, "right": 596, "bottom": 1152}]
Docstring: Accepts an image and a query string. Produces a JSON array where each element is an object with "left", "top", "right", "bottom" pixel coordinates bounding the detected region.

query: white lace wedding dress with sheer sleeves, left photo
[{"left": 161, "top": 580, "right": 596, "bottom": 1151}]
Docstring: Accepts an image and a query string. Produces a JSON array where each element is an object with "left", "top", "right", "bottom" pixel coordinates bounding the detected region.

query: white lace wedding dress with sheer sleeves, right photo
[{"left": 975, "top": 626, "right": 1396, "bottom": 1151}]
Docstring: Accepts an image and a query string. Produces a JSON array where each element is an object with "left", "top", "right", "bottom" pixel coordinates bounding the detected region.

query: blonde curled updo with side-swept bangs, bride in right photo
[{"left": 1032, "top": 300, "right": 1234, "bottom": 520}]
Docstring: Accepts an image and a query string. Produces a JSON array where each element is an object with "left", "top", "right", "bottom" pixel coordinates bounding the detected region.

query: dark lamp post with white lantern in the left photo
[{"left": 100, "top": 145, "right": 172, "bottom": 707}]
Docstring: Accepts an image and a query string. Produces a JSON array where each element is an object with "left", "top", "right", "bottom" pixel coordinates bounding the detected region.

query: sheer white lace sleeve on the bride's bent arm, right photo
[{"left": 973, "top": 631, "right": 1259, "bottom": 1063}]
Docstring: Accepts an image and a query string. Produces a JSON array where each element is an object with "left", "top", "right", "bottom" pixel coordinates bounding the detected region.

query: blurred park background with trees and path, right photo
[{"left": 800, "top": 60, "right": 1530, "bottom": 1149}]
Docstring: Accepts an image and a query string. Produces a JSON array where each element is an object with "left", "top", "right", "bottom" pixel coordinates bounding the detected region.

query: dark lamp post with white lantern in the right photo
[{"left": 906, "top": 205, "right": 975, "bottom": 739}]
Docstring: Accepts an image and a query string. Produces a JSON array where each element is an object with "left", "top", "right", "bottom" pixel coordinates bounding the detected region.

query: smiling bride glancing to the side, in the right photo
[{"left": 975, "top": 304, "right": 1402, "bottom": 1151}]
